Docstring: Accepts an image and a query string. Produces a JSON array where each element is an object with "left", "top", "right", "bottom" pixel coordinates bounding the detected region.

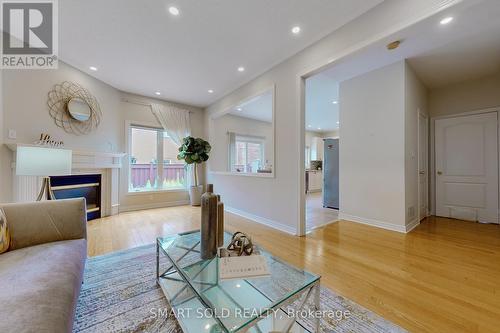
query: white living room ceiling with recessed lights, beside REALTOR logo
[{"left": 59, "top": 0, "right": 382, "bottom": 106}]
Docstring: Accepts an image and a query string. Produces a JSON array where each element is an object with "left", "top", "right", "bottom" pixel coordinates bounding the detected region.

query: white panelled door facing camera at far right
[{"left": 435, "top": 112, "right": 498, "bottom": 223}]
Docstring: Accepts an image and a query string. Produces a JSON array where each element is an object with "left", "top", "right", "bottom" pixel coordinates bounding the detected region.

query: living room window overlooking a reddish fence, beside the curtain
[{"left": 129, "top": 125, "right": 186, "bottom": 192}]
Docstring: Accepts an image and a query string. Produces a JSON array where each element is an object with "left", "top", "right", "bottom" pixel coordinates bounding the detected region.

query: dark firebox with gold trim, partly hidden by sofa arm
[{"left": 50, "top": 174, "right": 102, "bottom": 221}]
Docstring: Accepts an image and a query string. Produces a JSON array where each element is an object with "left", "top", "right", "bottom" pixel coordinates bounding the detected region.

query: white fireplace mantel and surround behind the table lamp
[{"left": 6, "top": 143, "right": 127, "bottom": 216}]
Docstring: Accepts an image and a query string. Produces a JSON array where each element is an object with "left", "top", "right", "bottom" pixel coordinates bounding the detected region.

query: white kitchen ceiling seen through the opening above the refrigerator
[{"left": 306, "top": 73, "right": 339, "bottom": 132}]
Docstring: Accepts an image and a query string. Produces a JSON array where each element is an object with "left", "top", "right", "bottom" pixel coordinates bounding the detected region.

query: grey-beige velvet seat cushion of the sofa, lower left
[{"left": 0, "top": 239, "right": 87, "bottom": 333}]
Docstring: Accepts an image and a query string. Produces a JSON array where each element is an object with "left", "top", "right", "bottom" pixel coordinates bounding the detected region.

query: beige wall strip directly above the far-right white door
[{"left": 429, "top": 72, "right": 500, "bottom": 117}]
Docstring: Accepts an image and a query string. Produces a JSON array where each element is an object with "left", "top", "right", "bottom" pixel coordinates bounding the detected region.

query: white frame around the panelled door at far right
[{"left": 428, "top": 106, "right": 500, "bottom": 220}]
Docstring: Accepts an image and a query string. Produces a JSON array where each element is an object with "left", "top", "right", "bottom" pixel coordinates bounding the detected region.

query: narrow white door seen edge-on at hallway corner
[{"left": 418, "top": 114, "right": 429, "bottom": 220}]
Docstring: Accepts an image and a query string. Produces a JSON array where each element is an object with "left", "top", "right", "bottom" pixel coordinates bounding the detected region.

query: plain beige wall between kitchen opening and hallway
[{"left": 339, "top": 61, "right": 405, "bottom": 231}]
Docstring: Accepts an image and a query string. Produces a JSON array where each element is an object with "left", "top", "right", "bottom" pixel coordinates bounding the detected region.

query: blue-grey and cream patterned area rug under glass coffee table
[{"left": 73, "top": 244, "right": 406, "bottom": 333}]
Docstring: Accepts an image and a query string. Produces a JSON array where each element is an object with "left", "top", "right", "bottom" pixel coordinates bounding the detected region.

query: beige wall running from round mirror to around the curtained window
[{"left": 0, "top": 62, "right": 204, "bottom": 210}]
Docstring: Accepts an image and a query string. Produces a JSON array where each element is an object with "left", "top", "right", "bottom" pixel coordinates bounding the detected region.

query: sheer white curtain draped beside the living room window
[{"left": 151, "top": 104, "right": 194, "bottom": 186}]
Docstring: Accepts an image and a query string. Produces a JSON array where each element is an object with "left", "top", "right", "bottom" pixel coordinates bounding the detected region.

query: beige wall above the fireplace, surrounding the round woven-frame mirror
[{"left": 2, "top": 62, "right": 123, "bottom": 201}]
